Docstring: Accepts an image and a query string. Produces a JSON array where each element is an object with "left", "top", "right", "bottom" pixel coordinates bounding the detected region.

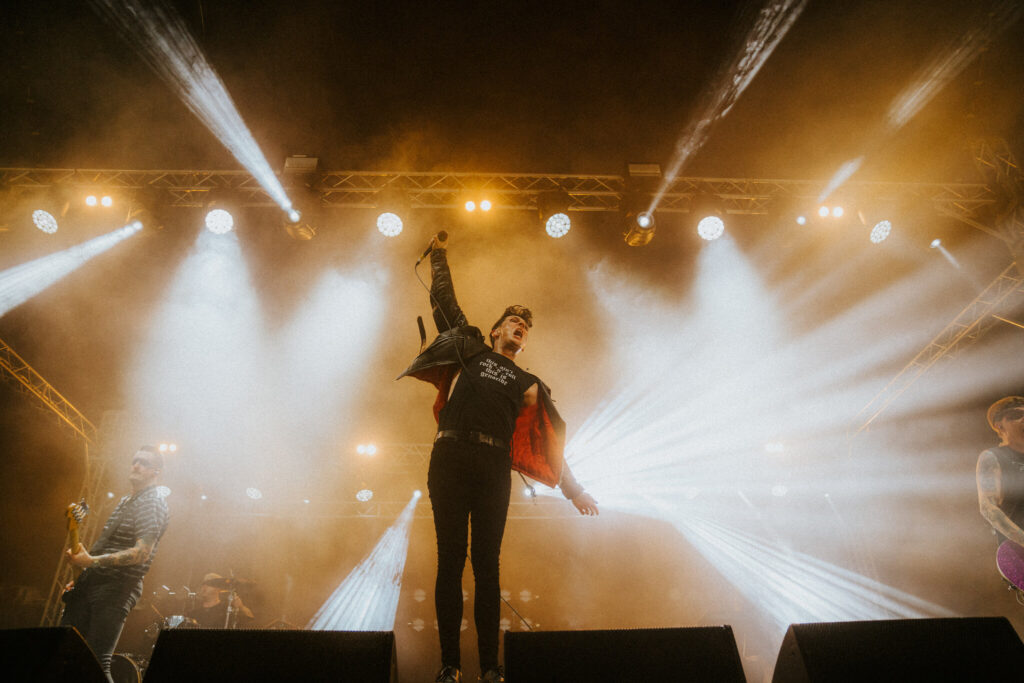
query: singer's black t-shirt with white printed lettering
[{"left": 438, "top": 350, "right": 537, "bottom": 443}]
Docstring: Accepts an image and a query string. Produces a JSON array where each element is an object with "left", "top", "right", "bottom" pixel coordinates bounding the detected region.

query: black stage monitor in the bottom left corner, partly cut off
[{"left": 0, "top": 626, "right": 106, "bottom": 683}]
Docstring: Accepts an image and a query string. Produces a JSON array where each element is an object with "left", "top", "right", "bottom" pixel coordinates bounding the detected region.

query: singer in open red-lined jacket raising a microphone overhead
[{"left": 399, "top": 231, "right": 598, "bottom": 683}]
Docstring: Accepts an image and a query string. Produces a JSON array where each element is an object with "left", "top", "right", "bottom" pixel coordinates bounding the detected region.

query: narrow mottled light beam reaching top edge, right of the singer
[{"left": 647, "top": 0, "right": 807, "bottom": 212}]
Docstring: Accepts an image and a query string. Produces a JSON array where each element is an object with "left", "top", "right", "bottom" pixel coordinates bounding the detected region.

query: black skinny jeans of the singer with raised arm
[{"left": 427, "top": 438, "right": 512, "bottom": 671}]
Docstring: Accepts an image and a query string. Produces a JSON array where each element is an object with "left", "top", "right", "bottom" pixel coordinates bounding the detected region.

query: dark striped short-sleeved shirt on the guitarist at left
[{"left": 89, "top": 486, "right": 169, "bottom": 584}]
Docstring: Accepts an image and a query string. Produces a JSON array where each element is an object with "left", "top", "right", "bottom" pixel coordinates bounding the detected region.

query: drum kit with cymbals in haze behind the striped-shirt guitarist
[{"left": 111, "top": 578, "right": 255, "bottom": 683}]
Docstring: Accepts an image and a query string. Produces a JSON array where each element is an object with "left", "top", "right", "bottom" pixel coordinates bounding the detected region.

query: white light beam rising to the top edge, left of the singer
[{"left": 90, "top": 0, "right": 292, "bottom": 212}]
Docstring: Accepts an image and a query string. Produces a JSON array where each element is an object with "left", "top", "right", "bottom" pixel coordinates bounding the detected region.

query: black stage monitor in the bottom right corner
[{"left": 772, "top": 617, "right": 1024, "bottom": 683}]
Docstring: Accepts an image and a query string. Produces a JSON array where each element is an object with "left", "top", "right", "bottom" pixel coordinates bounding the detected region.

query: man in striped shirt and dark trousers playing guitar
[{"left": 60, "top": 445, "right": 168, "bottom": 681}]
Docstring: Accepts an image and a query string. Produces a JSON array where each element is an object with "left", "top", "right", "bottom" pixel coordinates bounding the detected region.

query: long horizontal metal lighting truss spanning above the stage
[{"left": 0, "top": 168, "right": 999, "bottom": 229}]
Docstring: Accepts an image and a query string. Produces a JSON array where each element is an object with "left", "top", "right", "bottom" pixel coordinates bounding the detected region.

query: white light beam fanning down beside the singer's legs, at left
[{"left": 306, "top": 492, "right": 420, "bottom": 631}]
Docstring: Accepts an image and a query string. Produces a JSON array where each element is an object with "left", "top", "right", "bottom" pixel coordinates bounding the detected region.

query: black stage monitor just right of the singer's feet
[{"left": 505, "top": 626, "right": 746, "bottom": 683}]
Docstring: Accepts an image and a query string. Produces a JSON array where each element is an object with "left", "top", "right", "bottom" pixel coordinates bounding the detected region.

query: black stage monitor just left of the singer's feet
[{"left": 142, "top": 629, "right": 397, "bottom": 683}]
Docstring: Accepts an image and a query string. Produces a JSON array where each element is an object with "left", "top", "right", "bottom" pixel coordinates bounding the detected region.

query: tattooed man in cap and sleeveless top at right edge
[{"left": 977, "top": 396, "right": 1024, "bottom": 588}]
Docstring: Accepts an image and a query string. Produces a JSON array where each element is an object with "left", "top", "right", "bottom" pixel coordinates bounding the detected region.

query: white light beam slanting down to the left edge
[{"left": 0, "top": 221, "right": 142, "bottom": 315}]
